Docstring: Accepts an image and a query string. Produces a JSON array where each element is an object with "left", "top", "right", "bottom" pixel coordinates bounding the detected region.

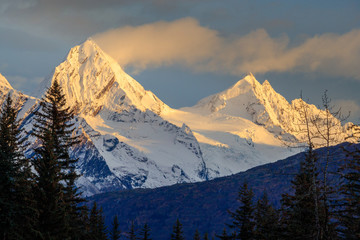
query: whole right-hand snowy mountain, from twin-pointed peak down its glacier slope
[{"left": 162, "top": 73, "right": 351, "bottom": 178}]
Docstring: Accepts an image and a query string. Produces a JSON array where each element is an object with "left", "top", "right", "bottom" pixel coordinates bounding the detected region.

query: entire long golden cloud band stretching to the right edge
[{"left": 93, "top": 17, "right": 360, "bottom": 80}]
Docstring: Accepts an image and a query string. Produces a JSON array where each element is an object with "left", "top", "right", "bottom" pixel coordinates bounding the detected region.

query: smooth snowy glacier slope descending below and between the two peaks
[{"left": 163, "top": 102, "right": 296, "bottom": 178}]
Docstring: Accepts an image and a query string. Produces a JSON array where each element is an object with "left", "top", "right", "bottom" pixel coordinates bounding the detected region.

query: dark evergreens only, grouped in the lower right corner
[{"left": 217, "top": 143, "right": 360, "bottom": 240}]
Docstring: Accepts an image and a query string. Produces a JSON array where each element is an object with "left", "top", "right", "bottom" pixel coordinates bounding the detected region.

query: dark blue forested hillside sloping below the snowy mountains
[{"left": 89, "top": 144, "right": 351, "bottom": 239}]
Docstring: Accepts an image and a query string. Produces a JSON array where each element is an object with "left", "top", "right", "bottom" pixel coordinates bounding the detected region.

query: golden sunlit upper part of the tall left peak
[{"left": 43, "top": 38, "right": 168, "bottom": 115}]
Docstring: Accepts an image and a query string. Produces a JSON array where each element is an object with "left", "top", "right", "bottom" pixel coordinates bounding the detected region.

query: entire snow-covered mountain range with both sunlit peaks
[{"left": 0, "top": 39, "right": 354, "bottom": 195}]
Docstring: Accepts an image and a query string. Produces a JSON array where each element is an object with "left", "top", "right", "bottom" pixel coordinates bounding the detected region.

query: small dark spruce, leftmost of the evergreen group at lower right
[{"left": 229, "top": 183, "right": 254, "bottom": 240}]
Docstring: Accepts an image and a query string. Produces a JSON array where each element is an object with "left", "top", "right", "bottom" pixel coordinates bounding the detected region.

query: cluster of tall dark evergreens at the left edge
[{"left": 0, "top": 81, "right": 106, "bottom": 240}]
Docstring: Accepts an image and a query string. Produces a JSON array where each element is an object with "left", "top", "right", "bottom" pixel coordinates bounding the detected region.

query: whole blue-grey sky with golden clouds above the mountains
[{"left": 0, "top": 0, "right": 360, "bottom": 123}]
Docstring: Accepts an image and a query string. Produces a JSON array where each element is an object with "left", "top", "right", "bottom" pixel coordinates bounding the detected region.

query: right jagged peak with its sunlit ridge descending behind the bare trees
[{"left": 183, "top": 73, "right": 346, "bottom": 144}]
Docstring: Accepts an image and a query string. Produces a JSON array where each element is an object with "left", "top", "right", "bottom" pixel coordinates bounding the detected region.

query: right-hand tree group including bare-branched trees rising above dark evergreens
[{"left": 212, "top": 94, "right": 360, "bottom": 240}]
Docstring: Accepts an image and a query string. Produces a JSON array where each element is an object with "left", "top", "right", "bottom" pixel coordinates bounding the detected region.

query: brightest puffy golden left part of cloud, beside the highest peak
[{"left": 93, "top": 18, "right": 220, "bottom": 70}]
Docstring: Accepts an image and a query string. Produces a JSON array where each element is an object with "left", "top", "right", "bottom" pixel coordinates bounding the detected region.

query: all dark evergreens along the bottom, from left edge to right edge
[{"left": 0, "top": 81, "right": 360, "bottom": 240}]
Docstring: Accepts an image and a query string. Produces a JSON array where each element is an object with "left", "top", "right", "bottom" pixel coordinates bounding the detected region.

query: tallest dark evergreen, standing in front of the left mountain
[{"left": 32, "top": 81, "right": 84, "bottom": 239}]
